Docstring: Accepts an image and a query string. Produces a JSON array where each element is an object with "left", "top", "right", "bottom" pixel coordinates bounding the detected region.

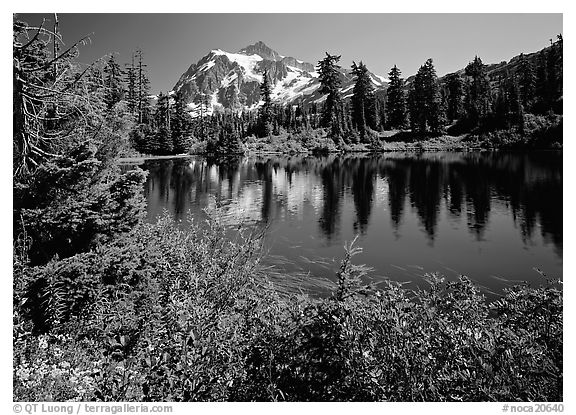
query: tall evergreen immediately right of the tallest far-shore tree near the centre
[{"left": 351, "top": 61, "right": 377, "bottom": 138}]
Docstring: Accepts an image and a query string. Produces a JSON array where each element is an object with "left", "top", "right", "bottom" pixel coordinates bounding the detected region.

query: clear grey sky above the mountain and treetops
[{"left": 15, "top": 13, "right": 562, "bottom": 93}]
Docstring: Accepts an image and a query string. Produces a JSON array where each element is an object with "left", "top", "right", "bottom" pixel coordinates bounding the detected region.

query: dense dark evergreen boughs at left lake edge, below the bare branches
[{"left": 14, "top": 143, "right": 146, "bottom": 264}]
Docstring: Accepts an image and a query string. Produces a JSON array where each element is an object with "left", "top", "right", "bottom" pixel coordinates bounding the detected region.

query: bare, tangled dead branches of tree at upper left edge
[{"left": 13, "top": 16, "right": 94, "bottom": 177}]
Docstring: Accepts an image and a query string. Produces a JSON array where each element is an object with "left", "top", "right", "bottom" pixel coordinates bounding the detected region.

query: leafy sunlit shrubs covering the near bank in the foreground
[{"left": 13, "top": 217, "right": 563, "bottom": 401}]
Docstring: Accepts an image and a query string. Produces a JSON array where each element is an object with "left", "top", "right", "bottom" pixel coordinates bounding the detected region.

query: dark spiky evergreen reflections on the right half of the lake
[{"left": 320, "top": 153, "right": 562, "bottom": 250}]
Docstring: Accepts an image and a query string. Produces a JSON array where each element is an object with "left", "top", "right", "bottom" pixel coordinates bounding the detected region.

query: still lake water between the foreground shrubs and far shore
[{"left": 122, "top": 152, "right": 562, "bottom": 298}]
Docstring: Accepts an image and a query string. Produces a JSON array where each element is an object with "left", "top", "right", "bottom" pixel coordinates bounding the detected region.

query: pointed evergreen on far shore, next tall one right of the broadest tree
[{"left": 465, "top": 56, "right": 491, "bottom": 125}]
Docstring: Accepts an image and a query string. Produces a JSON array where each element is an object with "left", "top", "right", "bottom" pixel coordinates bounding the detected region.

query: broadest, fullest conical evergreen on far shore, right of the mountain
[{"left": 409, "top": 59, "right": 443, "bottom": 134}]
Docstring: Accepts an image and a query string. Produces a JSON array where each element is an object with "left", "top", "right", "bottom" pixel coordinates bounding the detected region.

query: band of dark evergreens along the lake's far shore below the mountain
[{"left": 104, "top": 35, "right": 563, "bottom": 155}]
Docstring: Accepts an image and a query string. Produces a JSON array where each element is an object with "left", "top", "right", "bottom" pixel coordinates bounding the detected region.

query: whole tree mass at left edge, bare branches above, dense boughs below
[{"left": 13, "top": 15, "right": 145, "bottom": 265}]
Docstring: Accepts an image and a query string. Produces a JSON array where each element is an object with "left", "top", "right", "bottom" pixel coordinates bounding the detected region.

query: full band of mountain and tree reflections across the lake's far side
[{"left": 140, "top": 153, "right": 562, "bottom": 256}]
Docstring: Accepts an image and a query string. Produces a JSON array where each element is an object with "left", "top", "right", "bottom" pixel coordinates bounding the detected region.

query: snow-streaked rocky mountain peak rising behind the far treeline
[{"left": 174, "top": 42, "right": 387, "bottom": 115}]
